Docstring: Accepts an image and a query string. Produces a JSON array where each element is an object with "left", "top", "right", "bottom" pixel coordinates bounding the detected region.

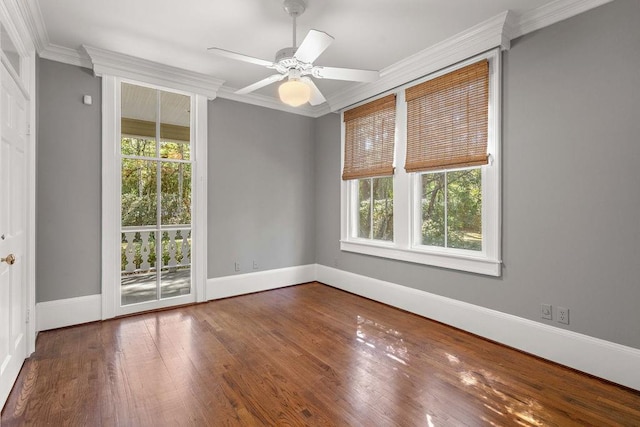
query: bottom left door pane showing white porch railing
[{"left": 120, "top": 231, "right": 158, "bottom": 305}]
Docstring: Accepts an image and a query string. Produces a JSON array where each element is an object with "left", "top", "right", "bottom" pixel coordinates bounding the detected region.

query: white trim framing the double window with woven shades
[{"left": 340, "top": 49, "right": 502, "bottom": 276}]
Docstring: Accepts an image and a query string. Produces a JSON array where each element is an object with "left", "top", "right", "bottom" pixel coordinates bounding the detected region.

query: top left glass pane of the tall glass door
[{"left": 120, "top": 83, "right": 158, "bottom": 157}]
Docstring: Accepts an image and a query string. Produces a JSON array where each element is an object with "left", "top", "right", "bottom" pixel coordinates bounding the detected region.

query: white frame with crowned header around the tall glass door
[{"left": 84, "top": 46, "right": 223, "bottom": 319}]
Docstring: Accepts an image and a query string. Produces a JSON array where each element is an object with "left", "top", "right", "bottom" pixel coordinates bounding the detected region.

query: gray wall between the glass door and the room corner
[{"left": 208, "top": 99, "right": 315, "bottom": 277}]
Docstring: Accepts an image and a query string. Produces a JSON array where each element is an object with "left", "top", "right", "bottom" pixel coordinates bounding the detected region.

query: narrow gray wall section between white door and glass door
[{"left": 36, "top": 59, "right": 102, "bottom": 302}]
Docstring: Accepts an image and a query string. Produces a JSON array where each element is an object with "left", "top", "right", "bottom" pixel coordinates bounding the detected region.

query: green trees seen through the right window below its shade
[{"left": 422, "top": 168, "right": 482, "bottom": 251}]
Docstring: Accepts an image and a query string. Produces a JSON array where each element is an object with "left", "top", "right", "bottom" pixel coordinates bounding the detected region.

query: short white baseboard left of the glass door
[{"left": 36, "top": 295, "right": 102, "bottom": 332}]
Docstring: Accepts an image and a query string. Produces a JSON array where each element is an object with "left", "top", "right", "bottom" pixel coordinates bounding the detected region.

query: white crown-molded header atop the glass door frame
[{"left": 82, "top": 45, "right": 224, "bottom": 99}]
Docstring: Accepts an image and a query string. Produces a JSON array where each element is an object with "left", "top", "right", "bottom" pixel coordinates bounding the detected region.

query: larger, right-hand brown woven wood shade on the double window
[{"left": 405, "top": 60, "right": 489, "bottom": 172}]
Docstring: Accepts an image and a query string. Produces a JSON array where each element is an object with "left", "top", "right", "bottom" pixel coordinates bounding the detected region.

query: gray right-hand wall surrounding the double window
[{"left": 316, "top": 0, "right": 640, "bottom": 348}]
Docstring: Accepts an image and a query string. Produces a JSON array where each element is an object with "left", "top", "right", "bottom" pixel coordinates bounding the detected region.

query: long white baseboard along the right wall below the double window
[{"left": 317, "top": 265, "right": 640, "bottom": 390}]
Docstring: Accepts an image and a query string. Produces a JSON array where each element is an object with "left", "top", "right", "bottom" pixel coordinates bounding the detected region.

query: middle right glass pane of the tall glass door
[{"left": 161, "top": 162, "right": 191, "bottom": 225}]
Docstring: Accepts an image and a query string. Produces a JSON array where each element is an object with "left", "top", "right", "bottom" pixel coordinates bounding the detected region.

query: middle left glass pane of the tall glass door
[{"left": 121, "top": 159, "right": 158, "bottom": 227}]
